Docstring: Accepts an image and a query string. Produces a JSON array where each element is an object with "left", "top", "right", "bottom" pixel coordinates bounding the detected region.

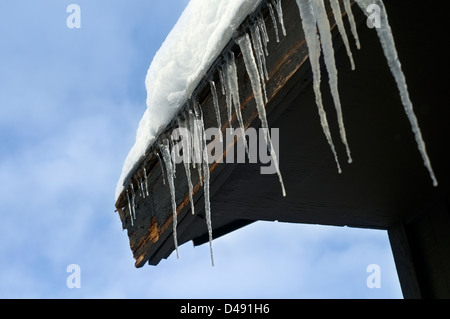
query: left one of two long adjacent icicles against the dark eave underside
[{"left": 297, "top": 0, "right": 342, "bottom": 174}]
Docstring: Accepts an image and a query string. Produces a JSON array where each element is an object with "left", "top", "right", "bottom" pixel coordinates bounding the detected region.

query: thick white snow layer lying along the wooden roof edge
[{"left": 116, "top": 0, "right": 261, "bottom": 200}]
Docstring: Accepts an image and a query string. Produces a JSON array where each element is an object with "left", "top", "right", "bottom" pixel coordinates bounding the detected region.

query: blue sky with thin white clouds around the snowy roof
[{"left": 0, "top": 0, "right": 402, "bottom": 298}]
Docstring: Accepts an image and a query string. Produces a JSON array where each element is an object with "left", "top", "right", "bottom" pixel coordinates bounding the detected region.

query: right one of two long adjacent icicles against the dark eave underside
[{"left": 312, "top": 0, "right": 352, "bottom": 163}]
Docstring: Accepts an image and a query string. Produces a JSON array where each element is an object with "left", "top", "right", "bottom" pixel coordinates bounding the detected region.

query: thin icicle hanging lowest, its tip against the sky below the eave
[{"left": 194, "top": 99, "right": 214, "bottom": 266}]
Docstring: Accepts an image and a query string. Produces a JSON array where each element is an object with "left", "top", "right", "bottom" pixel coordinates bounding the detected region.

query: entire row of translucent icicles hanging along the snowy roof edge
[{"left": 124, "top": 0, "right": 437, "bottom": 266}]
